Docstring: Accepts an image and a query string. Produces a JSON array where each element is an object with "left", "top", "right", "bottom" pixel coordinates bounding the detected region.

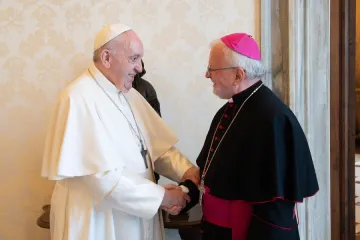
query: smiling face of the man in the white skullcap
[{"left": 109, "top": 31, "right": 144, "bottom": 92}]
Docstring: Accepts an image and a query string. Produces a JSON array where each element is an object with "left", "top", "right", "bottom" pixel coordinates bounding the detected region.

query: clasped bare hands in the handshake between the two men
[{"left": 161, "top": 167, "right": 200, "bottom": 215}]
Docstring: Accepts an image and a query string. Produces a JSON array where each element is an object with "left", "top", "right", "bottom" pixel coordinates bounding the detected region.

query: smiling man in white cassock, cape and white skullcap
[{"left": 42, "top": 24, "right": 199, "bottom": 240}]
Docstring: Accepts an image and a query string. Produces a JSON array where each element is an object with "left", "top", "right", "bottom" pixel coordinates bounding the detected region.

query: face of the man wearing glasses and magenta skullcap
[{"left": 205, "top": 45, "right": 237, "bottom": 99}]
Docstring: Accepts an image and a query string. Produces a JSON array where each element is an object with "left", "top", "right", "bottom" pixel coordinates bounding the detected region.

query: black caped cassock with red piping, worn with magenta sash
[{"left": 197, "top": 81, "right": 319, "bottom": 240}]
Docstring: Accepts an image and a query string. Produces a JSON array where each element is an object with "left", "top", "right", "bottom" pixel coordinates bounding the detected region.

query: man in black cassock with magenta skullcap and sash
[{"left": 197, "top": 33, "right": 319, "bottom": 240}]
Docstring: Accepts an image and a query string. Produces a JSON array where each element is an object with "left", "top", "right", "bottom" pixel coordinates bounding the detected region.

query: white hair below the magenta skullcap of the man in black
[{"left": 210, "top": 39, "right": 266, "bottom": 80}]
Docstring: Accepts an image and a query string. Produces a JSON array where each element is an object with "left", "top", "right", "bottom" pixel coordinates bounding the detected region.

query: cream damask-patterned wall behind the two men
[{"left": 0, "top": 0, "right": 260, "bottom": 240}]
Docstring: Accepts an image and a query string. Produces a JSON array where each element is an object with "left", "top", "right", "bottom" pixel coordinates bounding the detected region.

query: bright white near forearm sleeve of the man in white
[{"left": 83, "top": 170, "right": 165, "bottom": 219}]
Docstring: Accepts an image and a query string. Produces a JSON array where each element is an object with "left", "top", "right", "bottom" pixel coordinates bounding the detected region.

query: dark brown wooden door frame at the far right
[{"left": 330, "top": 0, "right": 356, "bottom": 240}]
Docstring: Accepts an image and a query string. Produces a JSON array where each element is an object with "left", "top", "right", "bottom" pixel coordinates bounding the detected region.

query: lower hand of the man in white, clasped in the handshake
[{"left": 161, "top": 184, "right": 190, "bottom": 208}]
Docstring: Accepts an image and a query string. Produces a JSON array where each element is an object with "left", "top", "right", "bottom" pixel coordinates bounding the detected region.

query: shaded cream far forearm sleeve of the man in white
[{"left": 154, "top": 147, "right": 194, "bottom": 183}]
